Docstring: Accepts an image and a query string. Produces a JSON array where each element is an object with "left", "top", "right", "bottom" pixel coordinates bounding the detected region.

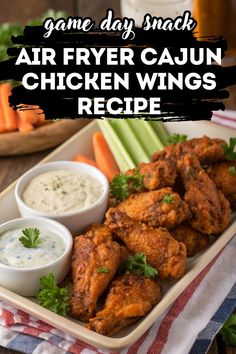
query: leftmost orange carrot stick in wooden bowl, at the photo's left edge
[{"left": 0, "top": 82, "right": 17, "bottom": 131}]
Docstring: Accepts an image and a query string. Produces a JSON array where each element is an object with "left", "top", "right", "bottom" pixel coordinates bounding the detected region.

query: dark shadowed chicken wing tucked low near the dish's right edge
[{"left": 171, "top": 223, "right": 210, "bottom": 257}]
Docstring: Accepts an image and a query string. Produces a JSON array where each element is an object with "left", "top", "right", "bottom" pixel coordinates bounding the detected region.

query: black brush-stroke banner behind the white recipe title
[{"left": 0, "top": 26, "right": 236, "bottom": 121}]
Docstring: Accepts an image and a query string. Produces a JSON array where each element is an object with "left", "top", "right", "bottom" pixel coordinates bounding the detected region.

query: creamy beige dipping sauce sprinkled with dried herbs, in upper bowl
[{"left": 22, "top": 170, "right": 103, "bottom": 215}]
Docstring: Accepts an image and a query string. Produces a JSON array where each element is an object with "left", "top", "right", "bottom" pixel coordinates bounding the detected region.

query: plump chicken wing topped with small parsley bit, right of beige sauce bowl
[{"left": 117, "top": 188, "right": 190, "bottom": 229}]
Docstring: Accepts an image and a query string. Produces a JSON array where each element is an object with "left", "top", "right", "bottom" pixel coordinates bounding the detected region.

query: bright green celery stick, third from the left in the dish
[{"left": 128, "top": 119, "right": 164, "bottom": 160}]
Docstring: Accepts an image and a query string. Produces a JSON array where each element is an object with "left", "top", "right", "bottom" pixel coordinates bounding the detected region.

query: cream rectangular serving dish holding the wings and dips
[{"left": 0, "top": 122, "right": 236, "bottom": 352}]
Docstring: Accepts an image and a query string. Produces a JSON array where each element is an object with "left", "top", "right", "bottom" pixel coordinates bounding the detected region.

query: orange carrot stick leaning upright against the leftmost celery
[{"left": 93, "top": 132, "right": 120, "bottom": 181}]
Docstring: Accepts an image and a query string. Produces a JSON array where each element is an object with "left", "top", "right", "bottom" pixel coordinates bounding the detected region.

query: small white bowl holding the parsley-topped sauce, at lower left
[{"left": 0, "top": 218, "right": 73, "bottom": 296}]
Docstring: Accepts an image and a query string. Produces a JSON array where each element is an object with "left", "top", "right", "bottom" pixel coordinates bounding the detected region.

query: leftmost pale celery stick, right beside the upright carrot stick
[{"left": 97, "top": 119, "right": 135, "bottom": 171}]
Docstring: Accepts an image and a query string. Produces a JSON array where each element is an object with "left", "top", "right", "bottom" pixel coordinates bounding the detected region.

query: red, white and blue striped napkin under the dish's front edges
[{"left": 0, "top": 237, "right": 236, "bottom": 354}]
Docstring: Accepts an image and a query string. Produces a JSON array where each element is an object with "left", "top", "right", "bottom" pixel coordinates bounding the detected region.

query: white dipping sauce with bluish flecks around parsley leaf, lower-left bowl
[{"left": 0, "top": 229, "right": 66, "bottom": 268}]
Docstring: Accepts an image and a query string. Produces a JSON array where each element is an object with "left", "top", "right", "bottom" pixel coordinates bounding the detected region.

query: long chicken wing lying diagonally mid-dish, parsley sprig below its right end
[{"left": 105, "top": 208, "right": 186, "bottom": 279}]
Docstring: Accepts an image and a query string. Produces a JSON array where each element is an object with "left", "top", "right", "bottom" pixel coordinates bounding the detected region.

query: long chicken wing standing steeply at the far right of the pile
[{"left": 177, "top": 155, "right": 231, "bottom": 235}]
